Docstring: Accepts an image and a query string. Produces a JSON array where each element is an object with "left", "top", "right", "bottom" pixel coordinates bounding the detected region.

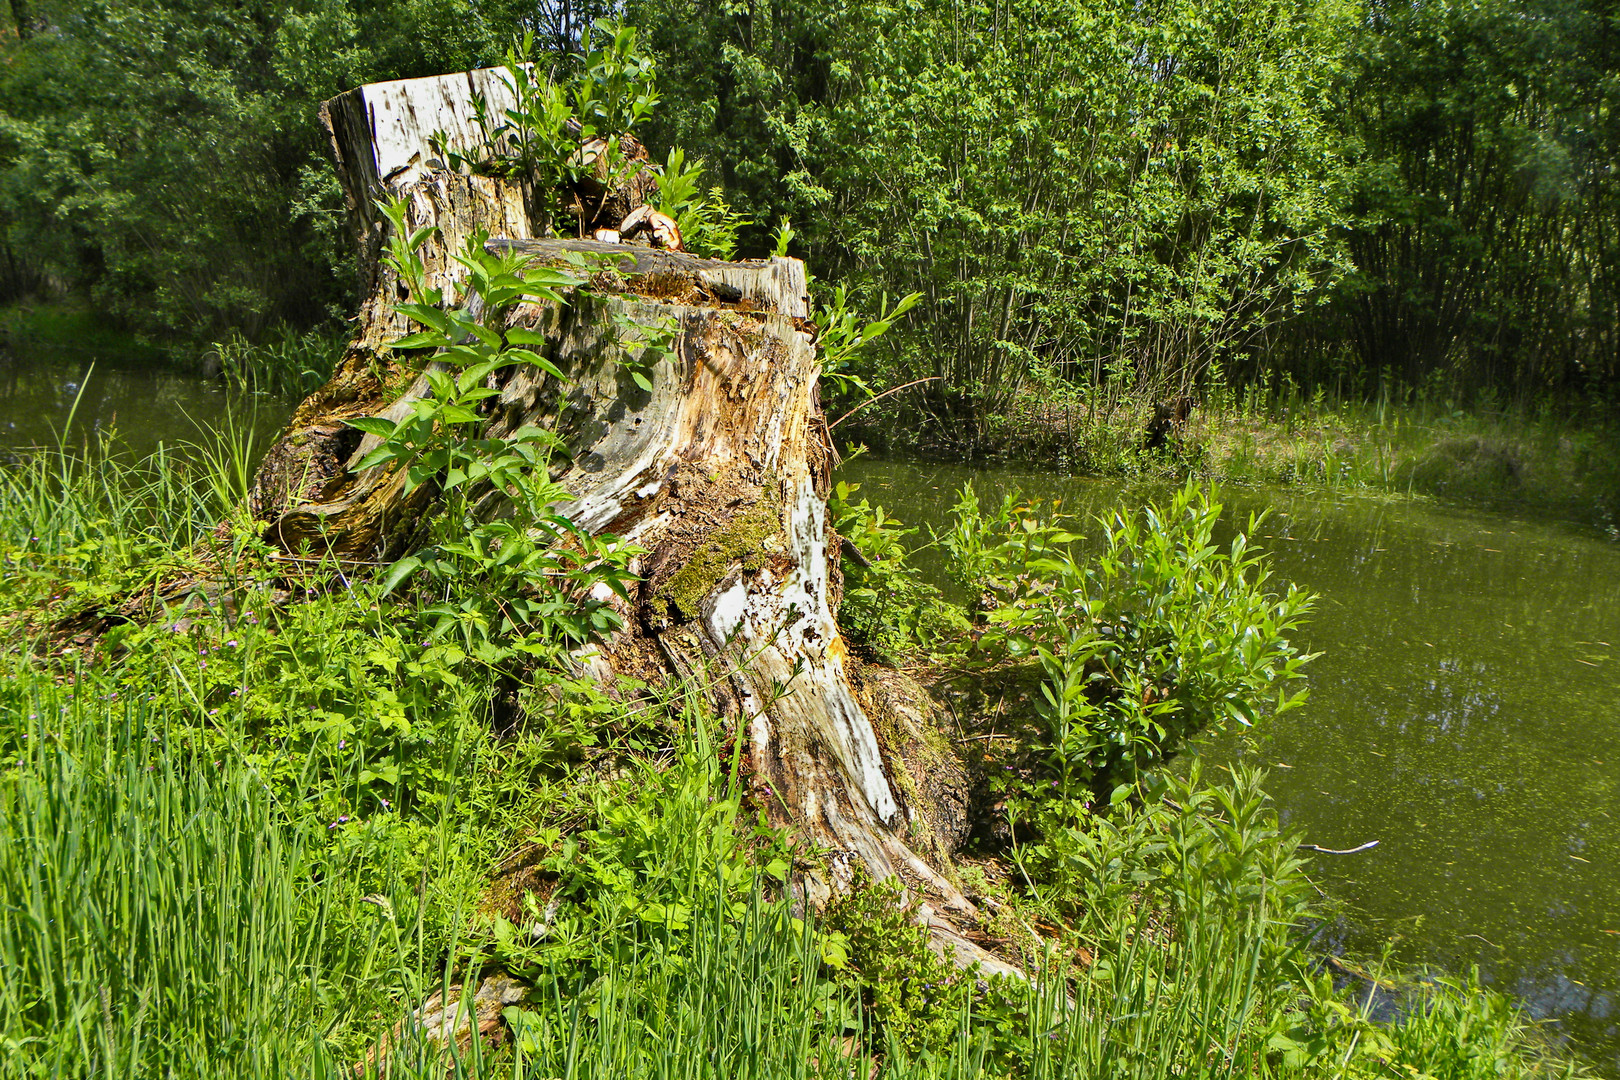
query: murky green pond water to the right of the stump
[{"left": 839, "top": 460, "right": 1620, "bottom": 1067}]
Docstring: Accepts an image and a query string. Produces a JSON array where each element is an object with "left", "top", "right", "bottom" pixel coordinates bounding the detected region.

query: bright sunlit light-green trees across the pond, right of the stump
[{"left": 632, "top": 0, "right": 1348, "bottom": 443}]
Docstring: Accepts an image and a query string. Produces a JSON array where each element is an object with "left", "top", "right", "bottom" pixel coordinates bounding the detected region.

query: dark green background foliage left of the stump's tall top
[{"left": 0, "top": 0, "right": 609, "bottom": 342}]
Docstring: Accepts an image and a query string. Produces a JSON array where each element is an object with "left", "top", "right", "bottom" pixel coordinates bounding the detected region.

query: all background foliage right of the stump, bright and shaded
[{"left": 629, "top": 0, "right": 1620, "bottom": 420}]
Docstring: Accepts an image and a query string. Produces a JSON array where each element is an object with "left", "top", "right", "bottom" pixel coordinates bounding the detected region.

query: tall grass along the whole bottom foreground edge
[{"left": 0, "top": 690, "right": 1558, "bottom": 1080}]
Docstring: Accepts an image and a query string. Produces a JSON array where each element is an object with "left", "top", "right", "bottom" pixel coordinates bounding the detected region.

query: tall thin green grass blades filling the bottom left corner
[{"left": 0, "top": 693, "right": 341, "bottom": 1075}]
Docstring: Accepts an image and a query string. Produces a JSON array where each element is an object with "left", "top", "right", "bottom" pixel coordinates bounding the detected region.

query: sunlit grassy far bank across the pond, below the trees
[{"left": 838, "top": 387, "right": 1620, "bottom": 536}]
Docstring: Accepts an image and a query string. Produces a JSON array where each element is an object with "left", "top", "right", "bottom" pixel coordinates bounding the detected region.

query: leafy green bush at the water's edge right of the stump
[{"left": 940, "top": 483, "right": 1312, "bottom": 803}]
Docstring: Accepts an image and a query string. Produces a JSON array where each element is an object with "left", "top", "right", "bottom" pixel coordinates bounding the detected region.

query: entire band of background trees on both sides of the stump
[{"left": 0, "top": 0, "right": 1620, "bottom": 417}]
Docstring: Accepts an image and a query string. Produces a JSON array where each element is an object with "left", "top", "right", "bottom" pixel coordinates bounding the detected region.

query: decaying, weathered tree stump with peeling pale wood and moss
[{"left": 251, "top": 71, "right": 1013, "bottom": 972}]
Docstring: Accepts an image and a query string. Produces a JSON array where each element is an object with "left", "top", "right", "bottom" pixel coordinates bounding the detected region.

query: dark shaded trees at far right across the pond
[{"left": 1338, "top": 0, "right": 1620, "bottom": 403}]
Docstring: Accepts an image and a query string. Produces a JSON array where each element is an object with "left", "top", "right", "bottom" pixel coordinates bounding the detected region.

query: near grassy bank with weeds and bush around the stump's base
[{"left": 0, "top": 433, "right": 1578, "bottom": 1078}]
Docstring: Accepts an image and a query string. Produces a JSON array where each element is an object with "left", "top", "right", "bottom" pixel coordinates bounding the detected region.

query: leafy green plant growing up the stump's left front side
[{"left": 348, "top": 201, "right": 640, "bottom": 662}]
